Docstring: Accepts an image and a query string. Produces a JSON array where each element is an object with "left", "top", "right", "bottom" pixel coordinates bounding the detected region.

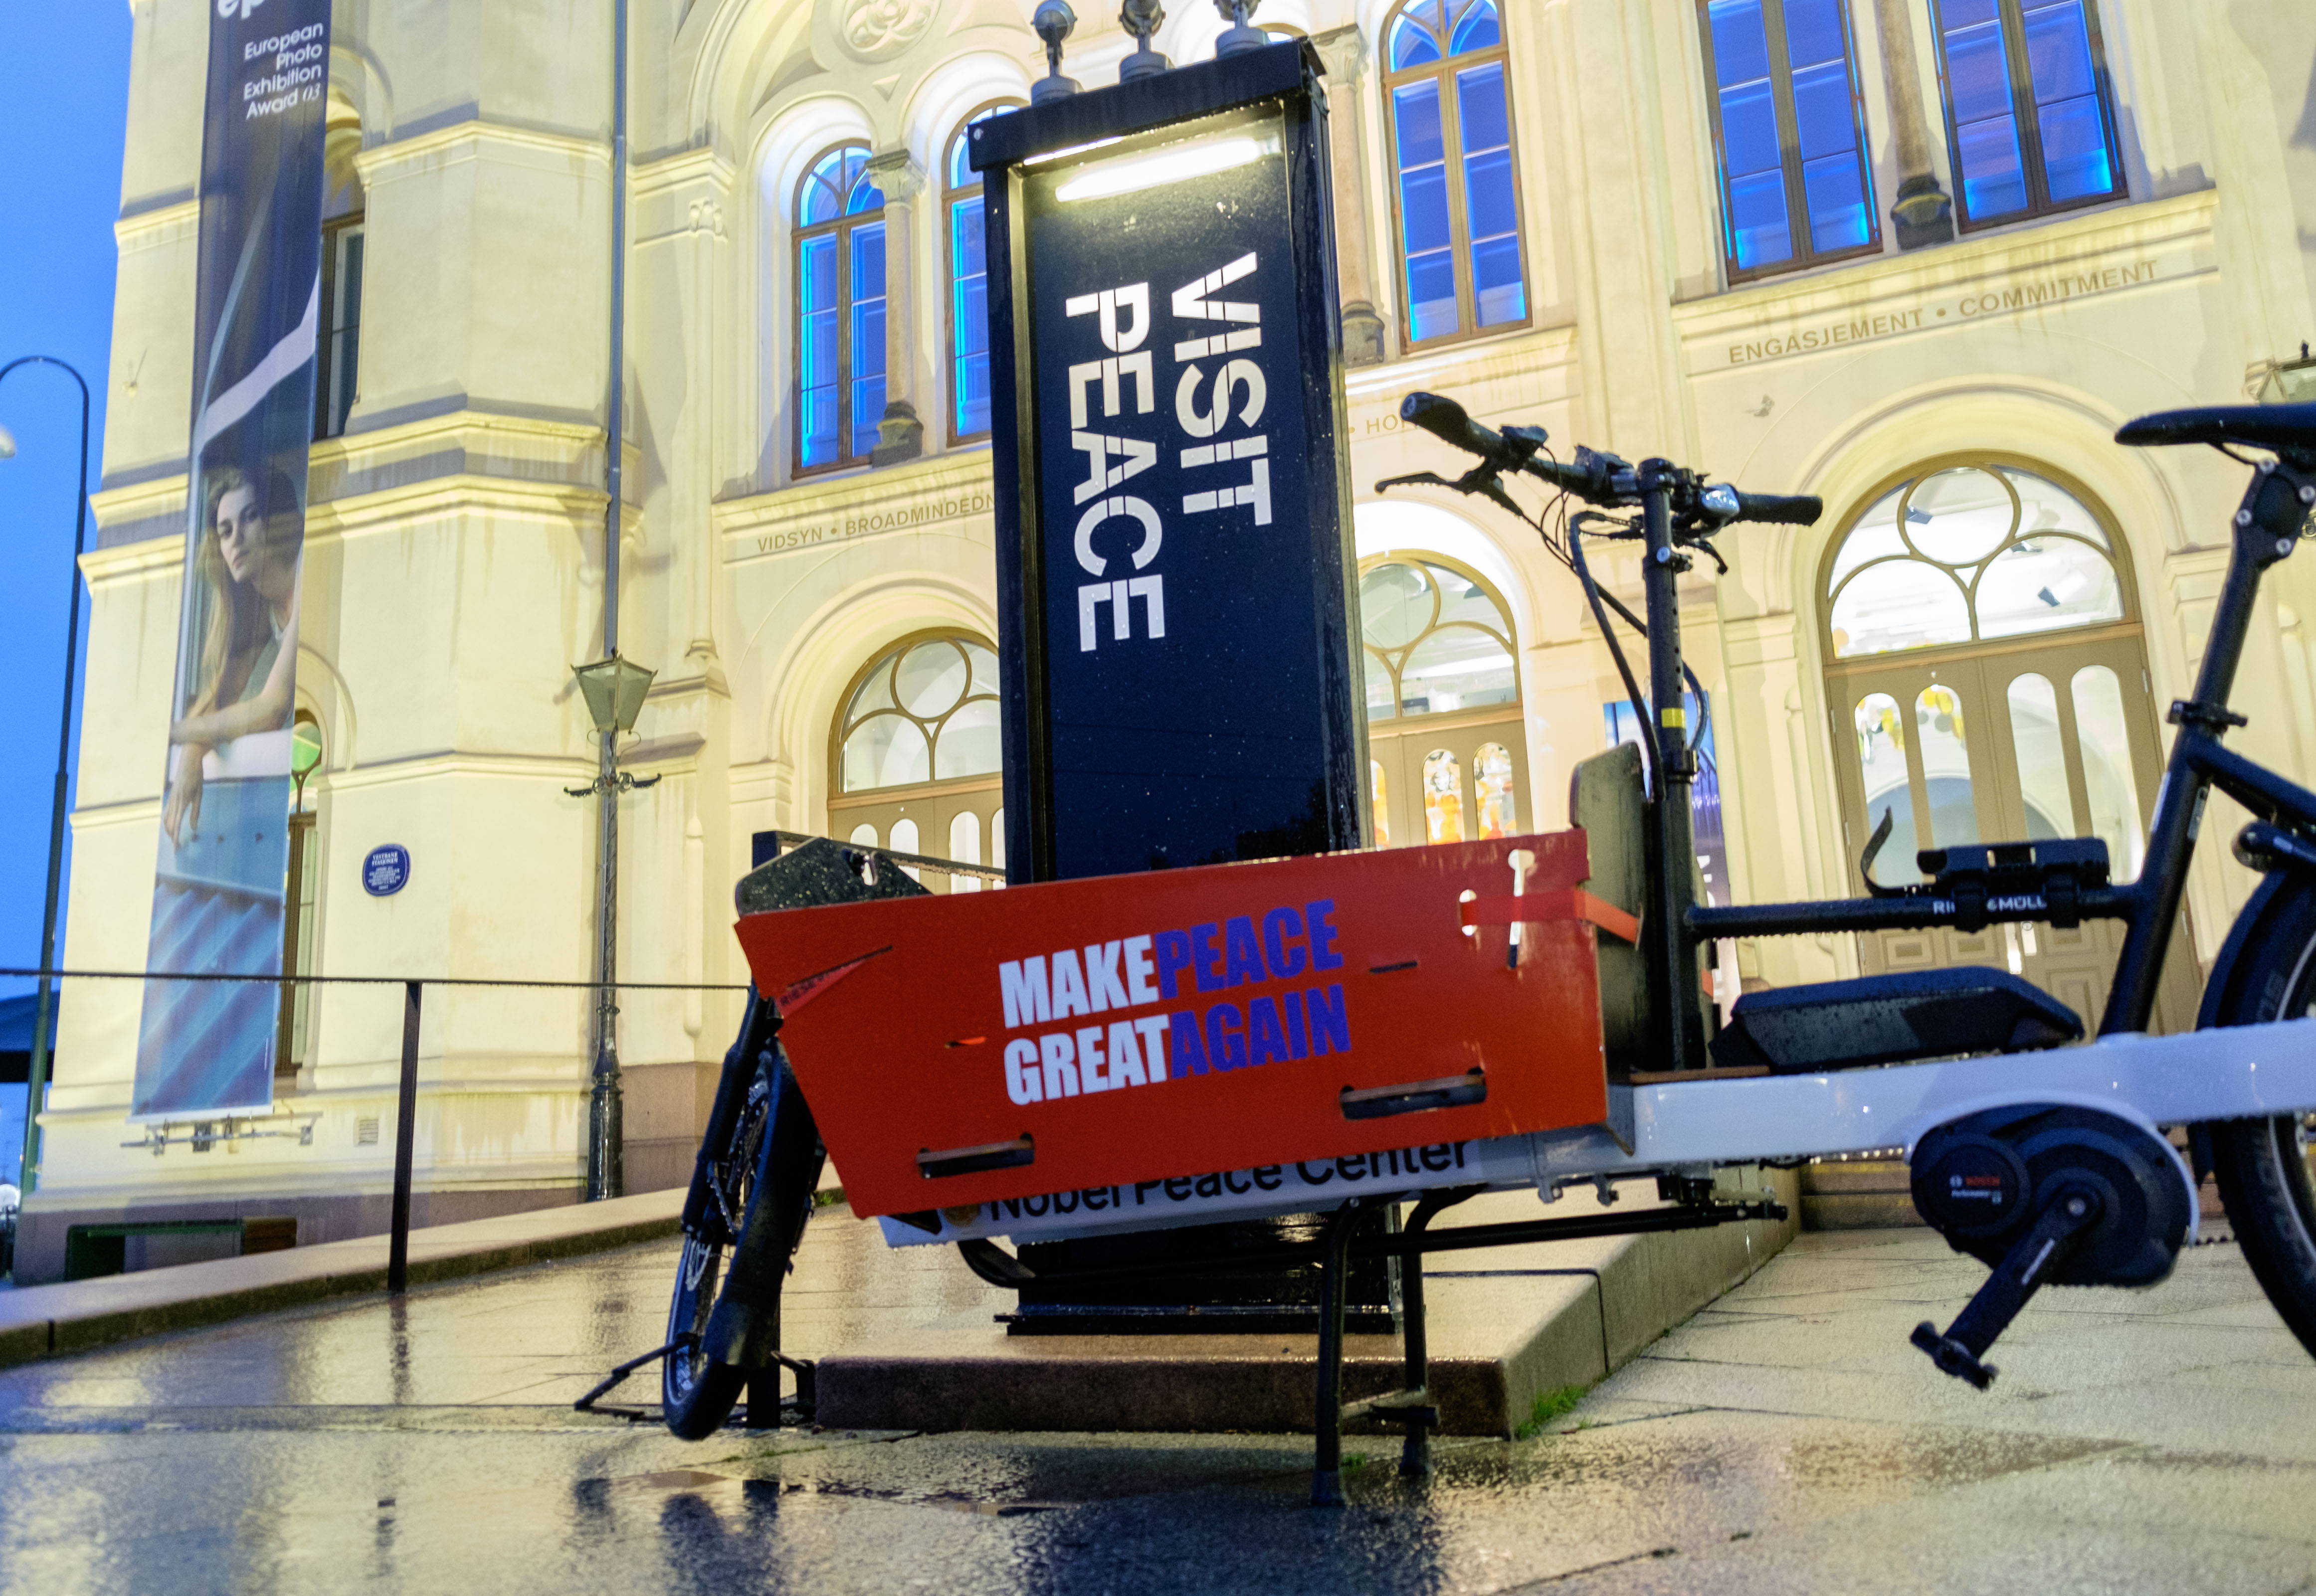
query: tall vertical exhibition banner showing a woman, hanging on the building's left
[{"left": 132, "top": 0, "right": 329, "bottom": 1119}]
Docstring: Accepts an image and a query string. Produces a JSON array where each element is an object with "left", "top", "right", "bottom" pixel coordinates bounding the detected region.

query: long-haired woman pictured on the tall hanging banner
[{"left": 162, "top": 466, "right": 306, "bottom": 846}]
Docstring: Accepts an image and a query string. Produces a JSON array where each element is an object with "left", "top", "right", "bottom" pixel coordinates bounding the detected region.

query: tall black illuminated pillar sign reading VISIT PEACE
[{"left": 970, "top": 42, "right": 1366, "bottom": 880}]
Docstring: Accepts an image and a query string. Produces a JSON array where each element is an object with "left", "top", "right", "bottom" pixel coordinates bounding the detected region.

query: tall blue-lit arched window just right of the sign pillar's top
[{"left": 1382, "top": 0, "right": 1529, "bottom": 345}]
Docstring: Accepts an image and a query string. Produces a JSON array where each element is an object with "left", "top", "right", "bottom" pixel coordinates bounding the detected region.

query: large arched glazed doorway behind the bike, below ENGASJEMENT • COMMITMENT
[{"left": 1818, "top": 456, "right": 2193, "bottom": 1024}]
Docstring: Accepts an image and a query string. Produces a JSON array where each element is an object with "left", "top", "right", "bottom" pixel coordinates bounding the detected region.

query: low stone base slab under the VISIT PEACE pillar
[{"left": 820, "top": 1170, "right": 1799, "bottom": 1436}]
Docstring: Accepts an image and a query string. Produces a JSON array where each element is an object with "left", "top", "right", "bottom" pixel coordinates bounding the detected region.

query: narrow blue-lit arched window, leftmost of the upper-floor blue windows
[{"left": 797, "top": 144, "right": 885, "bottom": 473}]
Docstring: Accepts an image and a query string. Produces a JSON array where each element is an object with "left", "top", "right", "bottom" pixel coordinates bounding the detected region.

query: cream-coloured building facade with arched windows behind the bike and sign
[{"left": 25, "top": 0, "right": 2316, "bottom": 1279}]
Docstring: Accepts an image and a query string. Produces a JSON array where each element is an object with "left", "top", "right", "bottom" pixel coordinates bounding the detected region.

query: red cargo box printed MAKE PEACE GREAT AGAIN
[{"left": 739, "top": 832, "right": 1633, "bottom": 1214}]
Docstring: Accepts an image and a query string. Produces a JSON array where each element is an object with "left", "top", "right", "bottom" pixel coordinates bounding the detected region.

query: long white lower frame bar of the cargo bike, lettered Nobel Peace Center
[{"left": 880, "top": 1019, "right": 2316, "bottom": 1246}]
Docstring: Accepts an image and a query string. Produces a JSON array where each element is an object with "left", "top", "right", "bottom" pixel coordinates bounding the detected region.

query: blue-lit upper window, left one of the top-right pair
[{"left": 1698, "top": 0, "right": 1881, "bottom": 283}]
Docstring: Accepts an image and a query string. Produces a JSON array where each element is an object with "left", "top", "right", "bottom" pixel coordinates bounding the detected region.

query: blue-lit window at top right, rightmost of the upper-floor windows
[{"left": 1931, "top": 0, "right": 2124, "bottom": 227}]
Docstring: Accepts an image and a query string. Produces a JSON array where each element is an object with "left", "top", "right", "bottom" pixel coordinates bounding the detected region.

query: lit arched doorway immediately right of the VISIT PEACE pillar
[{"left": 1359, "top": 553, "right": 1529, "bottom": 848}]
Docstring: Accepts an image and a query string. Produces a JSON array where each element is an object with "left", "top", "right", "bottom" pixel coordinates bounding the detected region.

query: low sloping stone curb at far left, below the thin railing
[{"left": 0, "top": 1191, "right": 683, "bottom": 1367}]
